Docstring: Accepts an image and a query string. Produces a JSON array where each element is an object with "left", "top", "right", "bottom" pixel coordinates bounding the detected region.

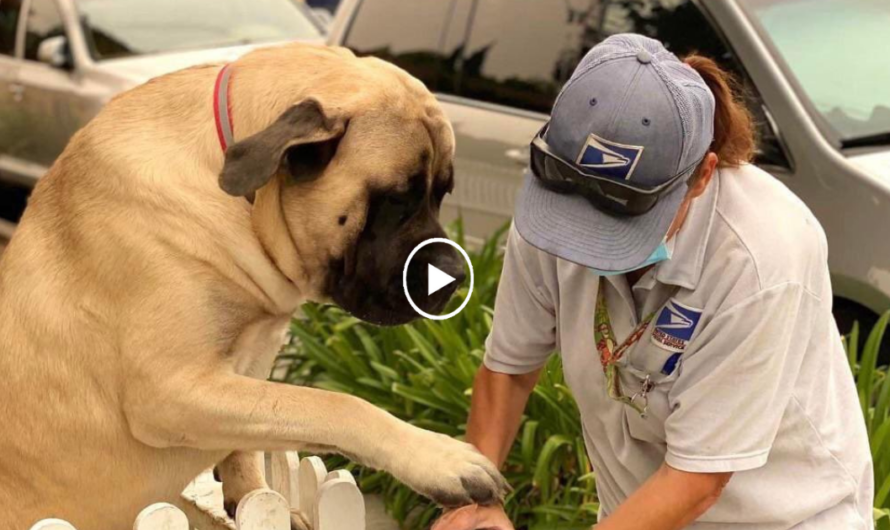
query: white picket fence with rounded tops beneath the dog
[{"left": 31, "top": 452, "right": 365, "bottom": 530}]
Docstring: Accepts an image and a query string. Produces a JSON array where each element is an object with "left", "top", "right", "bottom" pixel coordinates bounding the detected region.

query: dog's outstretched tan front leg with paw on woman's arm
[{"left": 125, "top": 372, "right": 506, "bottom": 507}]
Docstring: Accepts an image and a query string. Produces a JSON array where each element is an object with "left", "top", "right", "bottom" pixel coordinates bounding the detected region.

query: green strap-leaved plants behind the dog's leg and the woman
[{"left": 279, "top": 224, "right": 890, "bottom": 530}]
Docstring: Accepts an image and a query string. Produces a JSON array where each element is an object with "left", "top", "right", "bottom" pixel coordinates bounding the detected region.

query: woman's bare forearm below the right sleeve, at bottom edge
[{"left": 596, "top": 464, "right": 732, "bottom": 530}]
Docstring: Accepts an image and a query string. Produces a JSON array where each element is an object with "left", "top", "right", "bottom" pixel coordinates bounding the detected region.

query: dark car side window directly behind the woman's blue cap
[{"left": 456, "top": 0, "right": 788, "bottom": 167}]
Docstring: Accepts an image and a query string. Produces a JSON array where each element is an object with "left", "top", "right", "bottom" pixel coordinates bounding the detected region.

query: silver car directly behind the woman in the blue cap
[{"left": 329, "top": 0, "right": 890, "bottom": 338}]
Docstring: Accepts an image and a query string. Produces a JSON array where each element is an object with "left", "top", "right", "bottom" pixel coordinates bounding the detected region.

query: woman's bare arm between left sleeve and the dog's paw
[{"left": 467, "top": 366, "right": 541, "bottom": 467}]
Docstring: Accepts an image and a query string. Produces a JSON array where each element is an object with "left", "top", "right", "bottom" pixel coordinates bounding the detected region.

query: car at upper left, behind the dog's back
[{"left": 0, "top": 0, "right": 324, "bottom": 237}]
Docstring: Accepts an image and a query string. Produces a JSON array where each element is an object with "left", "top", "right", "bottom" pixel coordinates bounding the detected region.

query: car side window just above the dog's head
[{"left": 344, "top": 0, "right": 475, "bottom": 94}]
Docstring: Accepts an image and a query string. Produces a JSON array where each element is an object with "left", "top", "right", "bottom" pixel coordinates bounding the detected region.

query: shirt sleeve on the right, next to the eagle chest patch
[{"left": 665, "top": 283, "right": 818, "bottom": 473}]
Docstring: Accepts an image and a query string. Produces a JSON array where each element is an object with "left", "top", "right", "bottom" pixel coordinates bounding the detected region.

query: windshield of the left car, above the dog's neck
[{"left": 77, "top": 0, "right": 321, "bottom": 60}]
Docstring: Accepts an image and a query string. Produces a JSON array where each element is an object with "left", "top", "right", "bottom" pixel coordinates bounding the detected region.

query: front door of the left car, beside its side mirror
[{"left": 12, "top": 0, "right": 83, "bottom": 169}]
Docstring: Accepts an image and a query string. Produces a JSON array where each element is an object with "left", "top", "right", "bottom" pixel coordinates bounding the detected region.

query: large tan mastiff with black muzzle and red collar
[{"left": 0, "top": 45, "right": 504, "bottom": 530}]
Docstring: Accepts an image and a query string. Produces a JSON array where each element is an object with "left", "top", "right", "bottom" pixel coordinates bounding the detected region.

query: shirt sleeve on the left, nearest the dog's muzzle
[{"left": 484, "top": 223, "right": 556, "bottom": 374}]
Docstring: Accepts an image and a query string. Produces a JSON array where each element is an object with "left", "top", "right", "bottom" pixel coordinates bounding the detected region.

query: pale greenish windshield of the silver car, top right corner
[{"left": 744, "top": 0, "right": 890, "bottom": 144}]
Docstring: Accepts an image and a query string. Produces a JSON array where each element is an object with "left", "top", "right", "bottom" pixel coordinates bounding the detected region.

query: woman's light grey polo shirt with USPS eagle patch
[{"left": 485, "top": 165, "right": 874, "bottom": 530}]
